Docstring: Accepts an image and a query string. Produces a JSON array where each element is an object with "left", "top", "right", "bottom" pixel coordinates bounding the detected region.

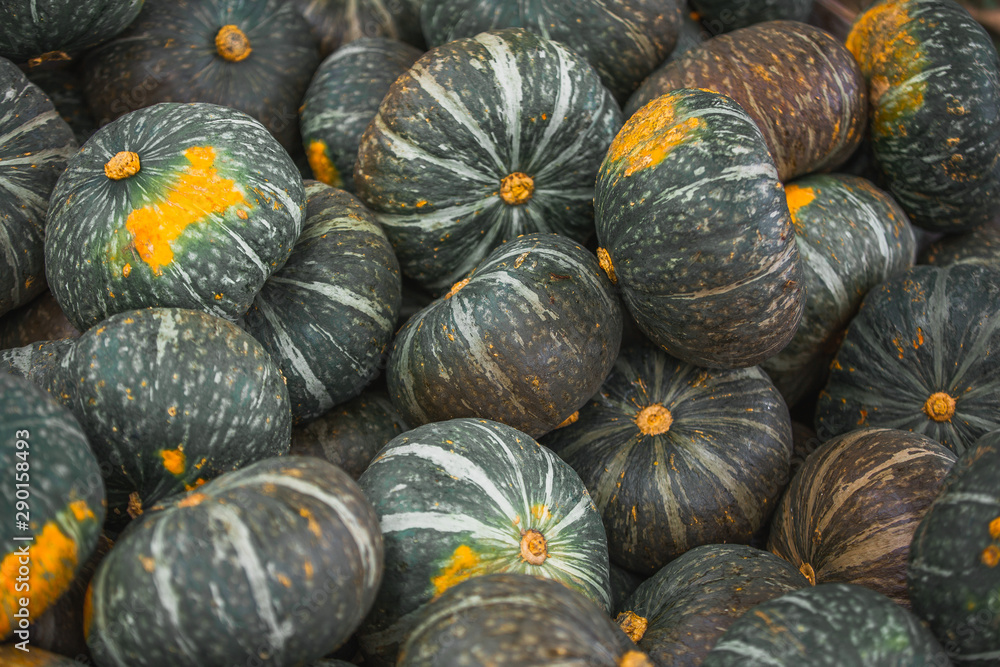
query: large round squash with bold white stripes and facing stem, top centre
[{"left": 354, "top": 28, "right": 621, "bottom": 293}]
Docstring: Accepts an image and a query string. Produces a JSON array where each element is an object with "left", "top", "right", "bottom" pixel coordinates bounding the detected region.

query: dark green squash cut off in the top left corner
[{"left": 0, "top": 0, "right": 143, "bottom": 63}]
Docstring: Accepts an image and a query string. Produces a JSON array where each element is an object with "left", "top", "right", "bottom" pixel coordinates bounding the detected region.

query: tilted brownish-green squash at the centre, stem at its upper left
[{"left": 386, "top": 234, "right": 622, "bottom": 437}]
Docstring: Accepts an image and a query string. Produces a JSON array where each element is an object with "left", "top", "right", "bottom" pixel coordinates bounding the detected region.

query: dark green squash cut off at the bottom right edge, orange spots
[{"left": 907, "top": 431, "right": 1000, "bottom": 667}]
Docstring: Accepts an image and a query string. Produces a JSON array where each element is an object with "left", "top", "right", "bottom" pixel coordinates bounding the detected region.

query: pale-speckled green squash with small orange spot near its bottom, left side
[{"left": 49, "top": 308, "right": 292, "bottom": 526}]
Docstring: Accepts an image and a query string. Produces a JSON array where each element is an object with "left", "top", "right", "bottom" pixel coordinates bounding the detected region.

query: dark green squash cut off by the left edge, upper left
[{"left": 0, "top": 56, "right": 77, "bottom": 315}]
